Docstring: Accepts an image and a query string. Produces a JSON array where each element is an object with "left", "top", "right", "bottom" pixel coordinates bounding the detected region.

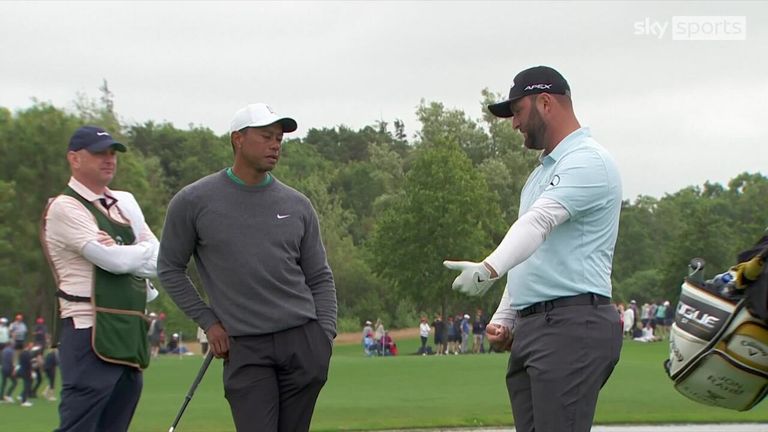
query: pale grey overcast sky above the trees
[{"left": 0, "top": 1, "right": 768, "bottom": 199}]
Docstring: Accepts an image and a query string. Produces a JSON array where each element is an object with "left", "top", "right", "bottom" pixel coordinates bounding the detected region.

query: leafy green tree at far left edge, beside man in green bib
[{"left": 0, "top": 103, "right": 81, "bottom": 317}]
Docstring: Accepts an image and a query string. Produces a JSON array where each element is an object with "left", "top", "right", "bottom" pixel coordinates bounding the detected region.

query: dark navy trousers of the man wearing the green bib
[{"left": 56, "top": 319, "right": 142, "bottom": 432}]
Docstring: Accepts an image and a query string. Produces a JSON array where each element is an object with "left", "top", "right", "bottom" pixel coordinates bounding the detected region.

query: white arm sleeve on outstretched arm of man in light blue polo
[{"left": 485, "top": 198, "right": 570, "bottom": 277}]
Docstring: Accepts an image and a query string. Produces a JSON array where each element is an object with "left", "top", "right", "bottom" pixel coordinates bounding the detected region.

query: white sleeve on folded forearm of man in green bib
[{"left": 82, "top": 241, "right": 158, "bottom": 277}]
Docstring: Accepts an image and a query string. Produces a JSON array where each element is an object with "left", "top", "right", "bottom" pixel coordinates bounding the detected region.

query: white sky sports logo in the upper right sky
[{"left": 634, "top": 15, "right": 747, "bottom": 41}]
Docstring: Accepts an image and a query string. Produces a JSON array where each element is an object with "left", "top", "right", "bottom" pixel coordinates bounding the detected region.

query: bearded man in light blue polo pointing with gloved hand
[{"left": 444, "top": 66, "right": 622, "bottom": 432}]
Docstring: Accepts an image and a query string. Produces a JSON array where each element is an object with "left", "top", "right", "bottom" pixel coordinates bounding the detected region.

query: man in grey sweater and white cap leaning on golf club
[{"left": 158, "top": 104, "right": 337, "bottom": 431}]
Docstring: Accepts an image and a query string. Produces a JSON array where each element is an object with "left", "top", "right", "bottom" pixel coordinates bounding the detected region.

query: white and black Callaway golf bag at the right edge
[{"left": 665, "top": 236, "right": 768, "bottom": 411}]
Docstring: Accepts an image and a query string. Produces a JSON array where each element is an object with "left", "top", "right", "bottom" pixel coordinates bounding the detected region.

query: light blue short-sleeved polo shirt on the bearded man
[{"left": 507, "top": 128, "right": 622, "bottom": 309}]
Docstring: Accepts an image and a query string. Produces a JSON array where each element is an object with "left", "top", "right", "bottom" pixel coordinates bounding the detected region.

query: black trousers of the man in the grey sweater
[{"left": 224, "top": 321, "right": 331, "bottom": 432}]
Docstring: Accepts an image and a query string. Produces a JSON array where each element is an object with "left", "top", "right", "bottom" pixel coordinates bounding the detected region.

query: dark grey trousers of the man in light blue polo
[{"left": 507, "top": 304, "right": 622, "bottom": 432}]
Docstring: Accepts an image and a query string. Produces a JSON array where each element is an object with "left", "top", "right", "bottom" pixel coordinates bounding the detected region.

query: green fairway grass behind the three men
[{"left": 0, "top": 340, "right": 768, "bottom": 432}]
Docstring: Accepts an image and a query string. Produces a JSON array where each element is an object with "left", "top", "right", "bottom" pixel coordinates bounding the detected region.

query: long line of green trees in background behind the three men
[{"left": 0, "top": 85, "right": 768, "bottom": 335}]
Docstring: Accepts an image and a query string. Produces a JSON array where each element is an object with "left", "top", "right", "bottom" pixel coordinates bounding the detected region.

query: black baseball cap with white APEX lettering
[{"left": 488, "top": 66, "right": 571, "bottom": 117}]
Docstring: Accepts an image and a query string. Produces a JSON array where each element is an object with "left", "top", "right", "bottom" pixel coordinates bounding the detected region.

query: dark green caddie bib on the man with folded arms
[{"left": 63, "top": 187, "right": 149, "bottom": 369}]
